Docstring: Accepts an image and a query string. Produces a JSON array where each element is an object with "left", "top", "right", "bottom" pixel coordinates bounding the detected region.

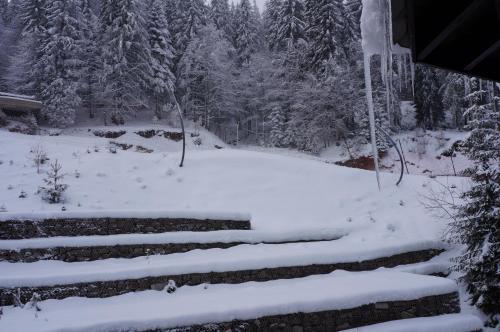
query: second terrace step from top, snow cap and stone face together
[{"left": 0, "top": 229, "right": 346, "bottom": 262}]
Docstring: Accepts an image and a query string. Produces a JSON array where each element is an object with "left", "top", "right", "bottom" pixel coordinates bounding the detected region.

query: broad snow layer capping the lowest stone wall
[{"left": 0, "top": 271, "right": 457, "bottom": 332}]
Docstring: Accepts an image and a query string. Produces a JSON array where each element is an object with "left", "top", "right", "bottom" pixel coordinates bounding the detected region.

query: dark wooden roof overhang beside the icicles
[{"left": 391, "top": 0, "right": 500, "bottom": 82}]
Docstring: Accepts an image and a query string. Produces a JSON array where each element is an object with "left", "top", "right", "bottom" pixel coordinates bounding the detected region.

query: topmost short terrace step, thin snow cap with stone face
[{"left": 0, "top": 211, "right": 251, "bottom": 240}]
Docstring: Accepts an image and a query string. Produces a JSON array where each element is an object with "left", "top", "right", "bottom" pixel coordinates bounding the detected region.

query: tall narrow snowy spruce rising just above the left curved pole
[{"left": 147, "top": 0, "right": 175, "bottom": 119}]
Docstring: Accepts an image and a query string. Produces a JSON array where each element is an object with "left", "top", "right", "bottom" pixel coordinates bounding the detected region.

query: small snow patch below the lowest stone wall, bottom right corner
[{"left": 345, "top": 314, "right": 483, "bottom": 332}]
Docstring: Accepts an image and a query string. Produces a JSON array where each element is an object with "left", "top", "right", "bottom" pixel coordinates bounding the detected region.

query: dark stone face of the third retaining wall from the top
[{"left": 0, "top": 249, "right": 443, "bottom": 306}]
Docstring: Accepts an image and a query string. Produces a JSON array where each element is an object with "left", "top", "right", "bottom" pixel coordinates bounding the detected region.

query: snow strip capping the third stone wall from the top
[{"left": 0, "top": 237, "right": 445, "bottom": 288}]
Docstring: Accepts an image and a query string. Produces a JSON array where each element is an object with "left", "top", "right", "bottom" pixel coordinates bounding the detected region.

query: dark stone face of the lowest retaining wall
[{"left": 148, "top": 293, "right": 460, "bottom": 332}]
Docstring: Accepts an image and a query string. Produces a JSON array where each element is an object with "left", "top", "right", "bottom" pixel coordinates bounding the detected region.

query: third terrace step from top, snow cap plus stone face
[{"left": 0, "top": 239, "right": 443, "bottom": 305}]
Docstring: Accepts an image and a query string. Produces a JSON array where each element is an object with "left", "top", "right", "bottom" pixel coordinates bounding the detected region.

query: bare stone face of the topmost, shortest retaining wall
[{"left": 0, "top": 218, "right": 251, "bottom": 240}]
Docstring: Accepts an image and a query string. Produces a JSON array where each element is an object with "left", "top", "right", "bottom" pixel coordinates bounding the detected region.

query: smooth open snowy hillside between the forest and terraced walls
[{"left": 0, "top": 127, "right": 465, "bottom": 241}]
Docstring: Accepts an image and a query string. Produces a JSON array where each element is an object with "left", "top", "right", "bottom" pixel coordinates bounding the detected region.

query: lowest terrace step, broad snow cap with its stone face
[{"left": 0, "top": 271, "right": 460, "bottom": 332}]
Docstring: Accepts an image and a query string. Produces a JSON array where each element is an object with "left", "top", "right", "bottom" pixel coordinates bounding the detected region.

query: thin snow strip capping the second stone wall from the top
[{"left": 0, "top": 228, "right": 347, "bottom": 250}]
